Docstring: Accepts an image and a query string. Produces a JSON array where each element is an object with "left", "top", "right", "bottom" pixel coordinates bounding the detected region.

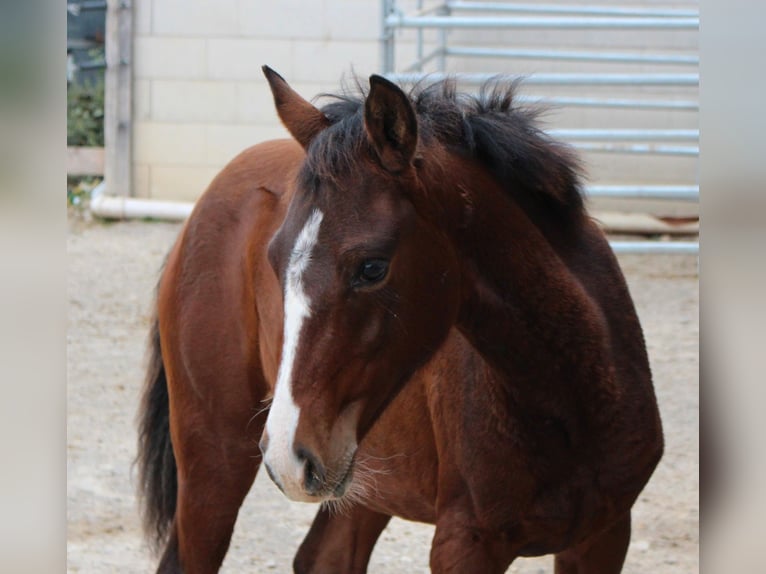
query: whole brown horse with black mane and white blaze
[{"left": 138, "top": 68, "right": 663, "bottom": 574}]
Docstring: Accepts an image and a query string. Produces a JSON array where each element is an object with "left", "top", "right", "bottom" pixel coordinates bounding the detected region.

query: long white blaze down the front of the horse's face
[{"left": 265, "top": 209, "right": 322, "bottom": 497}]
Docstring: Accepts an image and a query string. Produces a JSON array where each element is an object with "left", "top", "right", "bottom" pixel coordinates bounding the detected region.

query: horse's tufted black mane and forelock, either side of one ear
[{"left": 306, "top": 79, "right": 583, "bottom": 216}]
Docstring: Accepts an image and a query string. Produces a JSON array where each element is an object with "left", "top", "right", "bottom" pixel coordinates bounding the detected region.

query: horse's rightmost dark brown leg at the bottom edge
[{"left": 555, "top": 512, "right": 630, "bottom": 574}]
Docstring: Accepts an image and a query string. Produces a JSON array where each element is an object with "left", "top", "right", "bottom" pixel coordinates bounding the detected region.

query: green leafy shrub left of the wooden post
[{"left": 67, "top": 81, "right": 104, "bottom": 147}]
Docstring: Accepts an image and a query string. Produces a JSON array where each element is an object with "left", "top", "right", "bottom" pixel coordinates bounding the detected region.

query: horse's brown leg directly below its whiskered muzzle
[{"left": 293, "top": 505, "right": 391, "bottom": 574}]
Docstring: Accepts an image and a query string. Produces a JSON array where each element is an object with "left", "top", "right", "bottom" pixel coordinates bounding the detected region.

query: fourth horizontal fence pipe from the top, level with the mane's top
[{"left": 386, "top": 72, "right": 699, "bottom": 86}]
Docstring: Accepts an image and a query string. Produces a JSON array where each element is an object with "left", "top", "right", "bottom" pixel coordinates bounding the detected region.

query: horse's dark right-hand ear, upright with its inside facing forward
[{"left": 364, "top": 75, "right": 418, "bottom": 173}]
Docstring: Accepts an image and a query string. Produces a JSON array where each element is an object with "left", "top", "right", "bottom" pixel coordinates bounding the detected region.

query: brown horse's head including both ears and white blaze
[{"left": 261, "top": 67, "right": 460, "bottom": 502}]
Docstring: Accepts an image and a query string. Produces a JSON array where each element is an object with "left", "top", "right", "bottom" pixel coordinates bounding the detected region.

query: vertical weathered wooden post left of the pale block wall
[{"left": 104, "top": 0, "right": 133, "bottom": 197}]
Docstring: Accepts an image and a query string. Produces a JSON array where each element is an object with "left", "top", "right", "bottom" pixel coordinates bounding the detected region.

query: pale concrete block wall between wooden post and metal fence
[{"left": 133, "top": 0, "right": 404, "bottom": 201}]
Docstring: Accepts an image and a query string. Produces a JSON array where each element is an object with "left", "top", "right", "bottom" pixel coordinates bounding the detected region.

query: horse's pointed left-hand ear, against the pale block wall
[{"left": 261, "top": 66, "right": 330, "bottom": 149}]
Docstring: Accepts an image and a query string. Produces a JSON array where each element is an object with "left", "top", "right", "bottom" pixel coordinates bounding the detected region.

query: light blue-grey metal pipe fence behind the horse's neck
[{"left": 381, "top": 0, "right": 699, "bottom": 254}]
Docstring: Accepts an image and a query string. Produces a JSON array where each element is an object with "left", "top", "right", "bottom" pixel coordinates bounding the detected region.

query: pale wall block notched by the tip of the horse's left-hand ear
[{"left": 207, "top": 38, "right": 293, "bottom": 81}]
